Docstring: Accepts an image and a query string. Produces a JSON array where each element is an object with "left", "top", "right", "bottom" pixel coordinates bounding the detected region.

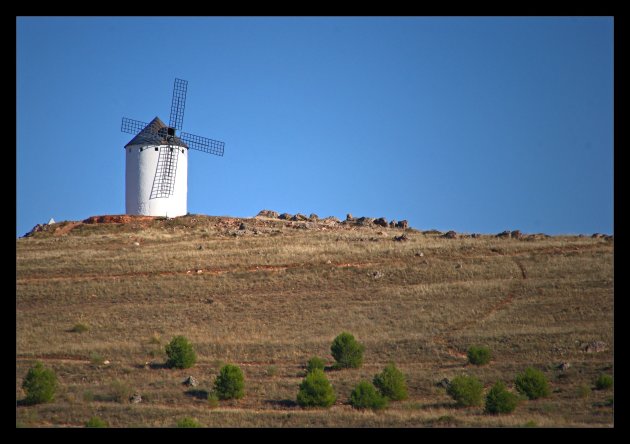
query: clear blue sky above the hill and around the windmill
[{"left": 16, "top": 17, "right": 613, "bottom": 236}]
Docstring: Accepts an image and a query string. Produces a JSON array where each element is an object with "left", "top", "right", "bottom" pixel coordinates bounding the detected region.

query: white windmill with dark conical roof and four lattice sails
[{"left": 120, "top": 78, "right": 225, "bottom": 217}]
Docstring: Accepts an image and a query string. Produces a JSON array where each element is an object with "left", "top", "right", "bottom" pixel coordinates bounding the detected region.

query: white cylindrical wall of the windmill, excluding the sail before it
[{"left": 125, "top": 145, "right": 188, "bottom": 217}]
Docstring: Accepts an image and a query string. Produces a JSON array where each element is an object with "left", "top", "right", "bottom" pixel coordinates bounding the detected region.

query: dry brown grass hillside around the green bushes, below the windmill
[{"left": 15, "top": 215, "right": 614, "bottom": 427}]
